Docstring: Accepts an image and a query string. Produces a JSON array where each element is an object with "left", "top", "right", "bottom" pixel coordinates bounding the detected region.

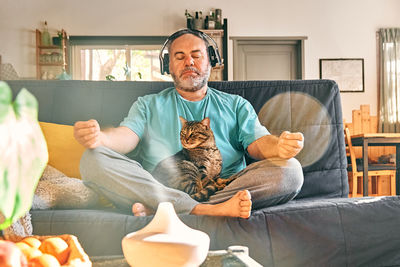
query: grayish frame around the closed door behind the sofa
[{"left": 229, "top": 36, "right": 308, "bottom": 80}]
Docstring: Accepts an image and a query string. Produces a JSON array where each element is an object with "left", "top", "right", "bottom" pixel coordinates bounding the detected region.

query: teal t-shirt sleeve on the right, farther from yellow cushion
[{"left": 237, "top": 98, "right": 270, "bottom": 149}]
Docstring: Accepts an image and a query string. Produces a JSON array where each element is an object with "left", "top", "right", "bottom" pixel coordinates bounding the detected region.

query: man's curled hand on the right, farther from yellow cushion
[{"left": 277, "top": 131, "right": 304, "bottom": 159}]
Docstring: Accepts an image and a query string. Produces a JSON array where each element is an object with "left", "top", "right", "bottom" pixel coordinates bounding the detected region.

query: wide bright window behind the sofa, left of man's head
[{"left": 70, "top": 36, "right": 172, "bottom": 81}]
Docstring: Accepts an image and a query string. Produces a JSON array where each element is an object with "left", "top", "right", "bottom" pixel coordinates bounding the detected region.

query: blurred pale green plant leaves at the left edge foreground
[{"left": 0, "top": 81, "right": 48, "bottom": 230}]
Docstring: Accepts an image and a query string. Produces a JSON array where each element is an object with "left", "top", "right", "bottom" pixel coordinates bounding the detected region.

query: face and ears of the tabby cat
[{"left": 181, "top": 117, "right": 212, "bottom": 149}]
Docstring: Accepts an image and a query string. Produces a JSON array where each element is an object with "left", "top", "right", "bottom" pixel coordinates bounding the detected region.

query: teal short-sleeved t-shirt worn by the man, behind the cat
[{"left": 120, "top": 88, "right": 269, "bottom": 177}]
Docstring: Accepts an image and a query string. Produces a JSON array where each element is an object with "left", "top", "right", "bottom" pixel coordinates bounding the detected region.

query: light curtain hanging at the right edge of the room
[{"left": 379, "top": 28, "right": 400, "bottom": 133}]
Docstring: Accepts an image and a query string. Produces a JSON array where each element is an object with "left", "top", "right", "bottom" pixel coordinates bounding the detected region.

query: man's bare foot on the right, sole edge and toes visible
[{"left": 191, "top": 190, "right": 251, "bottom": 218}]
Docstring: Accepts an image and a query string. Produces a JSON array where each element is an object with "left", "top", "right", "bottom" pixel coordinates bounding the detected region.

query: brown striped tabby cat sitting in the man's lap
[{"left": 152, "top": 117, "right": 233, "bottom": 201}]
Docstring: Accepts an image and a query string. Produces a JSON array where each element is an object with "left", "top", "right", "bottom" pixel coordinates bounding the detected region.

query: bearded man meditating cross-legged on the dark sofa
[{"left": 74, "top": 30, "right": 304, "bottom": 218}]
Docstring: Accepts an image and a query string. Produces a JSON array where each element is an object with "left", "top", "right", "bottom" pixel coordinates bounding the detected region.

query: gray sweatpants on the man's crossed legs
[{"left": 80, "top": 147, "right": 303, "bottom": 214}]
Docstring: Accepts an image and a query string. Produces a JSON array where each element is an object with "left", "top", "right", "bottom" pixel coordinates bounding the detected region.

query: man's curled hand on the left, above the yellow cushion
[{"left": 74, "top": 120, "right": 103, "bottom": 148}]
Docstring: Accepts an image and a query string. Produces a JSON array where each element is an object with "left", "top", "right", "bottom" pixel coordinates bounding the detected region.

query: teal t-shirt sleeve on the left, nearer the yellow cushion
[{"left": 120, "top": 97, "right": 147, "bottom": 139}]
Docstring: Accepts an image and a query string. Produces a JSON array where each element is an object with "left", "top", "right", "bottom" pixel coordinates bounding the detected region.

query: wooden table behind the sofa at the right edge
[{"left": 351, "top": 133, "right": 400, "bottom": 196}]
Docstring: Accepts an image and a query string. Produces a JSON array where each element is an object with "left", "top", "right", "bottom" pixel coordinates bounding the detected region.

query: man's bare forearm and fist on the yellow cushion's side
[{"left": 74, "top": 120, "right": 139, "bottom": 154}]
